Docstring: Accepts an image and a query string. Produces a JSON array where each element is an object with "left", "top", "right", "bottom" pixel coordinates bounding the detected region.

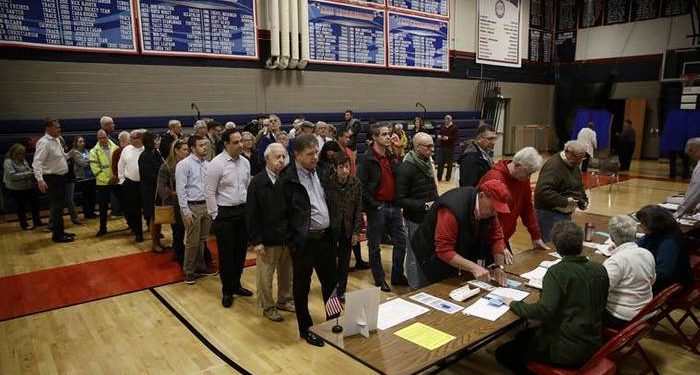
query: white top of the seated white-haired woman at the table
[{"left": 603, "top": 242, "right": 656, "bottom": 321}]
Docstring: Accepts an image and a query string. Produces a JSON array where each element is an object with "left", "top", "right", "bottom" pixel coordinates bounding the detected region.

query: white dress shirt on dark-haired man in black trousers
[{"left": 204, "top": 150, "right": 250, "bottom": 219}]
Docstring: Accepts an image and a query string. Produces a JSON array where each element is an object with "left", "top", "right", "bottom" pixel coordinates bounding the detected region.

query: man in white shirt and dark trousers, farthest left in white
[{"left": 32, "top": 119, "right": 77, "bottom": 242}]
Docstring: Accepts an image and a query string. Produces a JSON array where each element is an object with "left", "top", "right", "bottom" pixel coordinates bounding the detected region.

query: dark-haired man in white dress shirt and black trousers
[{"left": 204, "top": 129, "right": 253, "bottom": 308}]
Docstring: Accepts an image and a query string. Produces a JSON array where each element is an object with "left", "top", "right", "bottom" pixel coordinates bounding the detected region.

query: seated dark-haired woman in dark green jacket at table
[{"left": 496, "top": 221, "right": 608, "bottom": 374}]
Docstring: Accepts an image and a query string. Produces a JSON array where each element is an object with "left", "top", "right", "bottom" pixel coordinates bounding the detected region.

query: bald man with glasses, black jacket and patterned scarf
[{"left": 396, "top": 133, "right": 438, "bottom": 289}]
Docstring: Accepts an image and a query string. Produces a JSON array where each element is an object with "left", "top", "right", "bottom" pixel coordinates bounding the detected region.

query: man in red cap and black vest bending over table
[{"left": 411, "top": 180, "right": 511, "bottom": 285}]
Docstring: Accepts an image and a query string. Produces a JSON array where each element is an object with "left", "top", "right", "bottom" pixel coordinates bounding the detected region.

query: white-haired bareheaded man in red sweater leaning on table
[{"left": 479, "top": 147, "right": 549, "bottom": 264}]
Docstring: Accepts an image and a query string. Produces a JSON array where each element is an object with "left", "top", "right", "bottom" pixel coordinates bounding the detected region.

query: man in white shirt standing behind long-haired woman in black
[{"left": 117, "top": 129, "right": 146, "bottom": 242}]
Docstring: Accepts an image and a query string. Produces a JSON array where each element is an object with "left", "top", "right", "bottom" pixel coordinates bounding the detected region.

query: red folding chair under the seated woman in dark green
[{"left": 527, "top": 320, "right": 651, "bottom": 375}]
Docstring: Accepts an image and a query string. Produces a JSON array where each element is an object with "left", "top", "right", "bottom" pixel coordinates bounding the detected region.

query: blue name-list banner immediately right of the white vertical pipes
[{"left": 309, "top": 0, "right": 386, "bottom": 67}]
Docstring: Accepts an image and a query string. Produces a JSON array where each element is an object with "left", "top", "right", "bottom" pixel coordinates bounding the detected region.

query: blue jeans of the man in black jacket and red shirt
[{"left": 367, "top": 204, "right": 406, "bottom": 286}]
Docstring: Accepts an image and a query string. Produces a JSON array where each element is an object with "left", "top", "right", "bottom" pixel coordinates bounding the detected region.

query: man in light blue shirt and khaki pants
[{"left": 175, "top": 135, "right": 217, "bottom": 285}]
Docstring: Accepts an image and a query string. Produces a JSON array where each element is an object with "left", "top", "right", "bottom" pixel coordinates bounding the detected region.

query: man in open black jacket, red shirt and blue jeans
[{"left": 357, "top": 123, "right": 408, "bottom": 292}]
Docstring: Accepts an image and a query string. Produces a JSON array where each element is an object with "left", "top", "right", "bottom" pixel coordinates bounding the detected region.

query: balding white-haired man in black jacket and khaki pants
[{"left": 246, "top": 143, "right": 295, "bottom": 322}]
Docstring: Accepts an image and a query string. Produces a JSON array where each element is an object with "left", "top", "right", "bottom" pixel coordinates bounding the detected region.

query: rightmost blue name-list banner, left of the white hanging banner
[{"left": 389, "top": 12, "right": 450, "bottom": 72}]
